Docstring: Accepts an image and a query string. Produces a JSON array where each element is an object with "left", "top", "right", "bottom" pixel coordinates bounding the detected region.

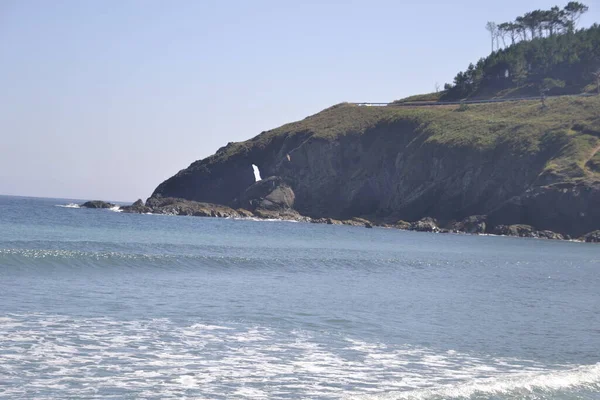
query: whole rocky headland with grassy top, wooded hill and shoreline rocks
[{"left": 84, "top": 20, "right": 600, "bottom": 242}]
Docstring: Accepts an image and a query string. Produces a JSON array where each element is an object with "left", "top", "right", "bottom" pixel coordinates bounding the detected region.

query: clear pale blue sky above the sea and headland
[{"left": 0, "top": 0, "right": 600, "bottom": 200}]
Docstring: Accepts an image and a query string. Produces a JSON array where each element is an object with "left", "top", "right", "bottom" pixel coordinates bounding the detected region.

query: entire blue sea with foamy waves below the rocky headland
[{"left": 0, "top": 196, "right": 600, "bottom": 399}]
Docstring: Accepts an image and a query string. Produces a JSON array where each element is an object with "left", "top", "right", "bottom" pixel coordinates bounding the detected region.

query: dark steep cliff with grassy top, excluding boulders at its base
[{"left": 152, "top": 98, "right": 600, "bottom": 235}]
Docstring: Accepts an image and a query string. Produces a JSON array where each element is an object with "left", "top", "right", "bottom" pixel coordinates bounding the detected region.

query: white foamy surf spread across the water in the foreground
[{"left": 0, "top": 314, "right": 600, "bottom": 400}]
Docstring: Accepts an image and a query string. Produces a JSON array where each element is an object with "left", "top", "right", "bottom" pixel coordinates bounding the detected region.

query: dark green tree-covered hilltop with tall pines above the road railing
[{"left": 440, "top": 2, "right": 600, "bottom": 101}]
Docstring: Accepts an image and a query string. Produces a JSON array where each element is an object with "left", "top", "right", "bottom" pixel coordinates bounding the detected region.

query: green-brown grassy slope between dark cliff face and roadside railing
[{"left": 243, "top": 96, "right": 600, "bottom": 181}]
